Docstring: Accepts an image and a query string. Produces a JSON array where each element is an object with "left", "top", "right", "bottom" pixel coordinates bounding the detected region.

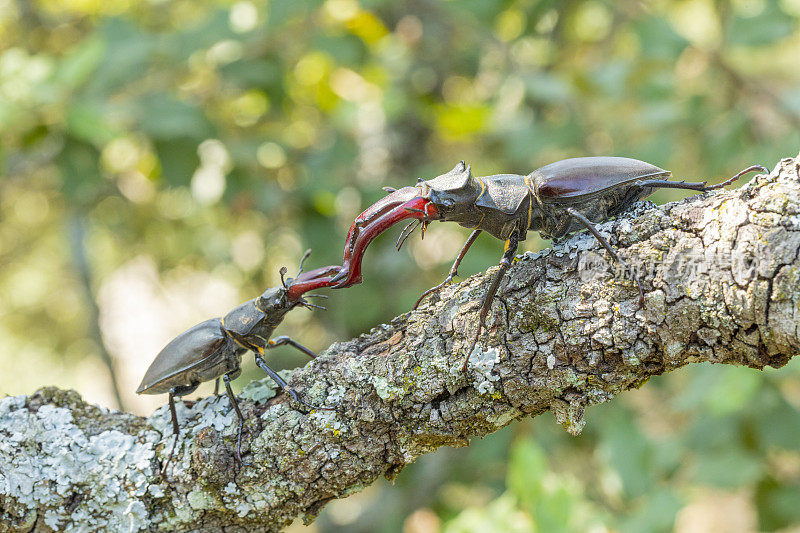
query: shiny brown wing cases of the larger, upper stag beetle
[{"left": 529, "top": 157, "right": 671, "bottom": 203}]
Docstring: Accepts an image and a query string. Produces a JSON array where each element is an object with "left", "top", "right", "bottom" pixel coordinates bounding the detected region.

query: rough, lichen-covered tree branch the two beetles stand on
[{"left": 0, "top": 152, "right": 800, "bottom": 531}]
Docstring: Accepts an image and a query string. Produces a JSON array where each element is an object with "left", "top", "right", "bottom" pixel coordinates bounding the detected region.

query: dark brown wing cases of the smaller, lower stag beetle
[{"left": 136, "top": 318, "right": 237, "bottom": 394}]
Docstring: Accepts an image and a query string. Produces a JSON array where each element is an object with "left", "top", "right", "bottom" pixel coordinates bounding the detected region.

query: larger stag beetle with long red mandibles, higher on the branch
[{"left": 332, "top": 157, "right": 769, "bottom": 371}]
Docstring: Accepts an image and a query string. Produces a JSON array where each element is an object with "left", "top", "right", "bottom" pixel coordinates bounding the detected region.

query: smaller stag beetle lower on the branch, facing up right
[{"left": 136, "top": 250, "right": 340, "bottom": 475}]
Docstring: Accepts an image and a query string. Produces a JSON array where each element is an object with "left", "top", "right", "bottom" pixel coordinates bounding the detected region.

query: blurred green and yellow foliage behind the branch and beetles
[{"left": 0, "top": 0, "right": 800, "bottom": 532}]
